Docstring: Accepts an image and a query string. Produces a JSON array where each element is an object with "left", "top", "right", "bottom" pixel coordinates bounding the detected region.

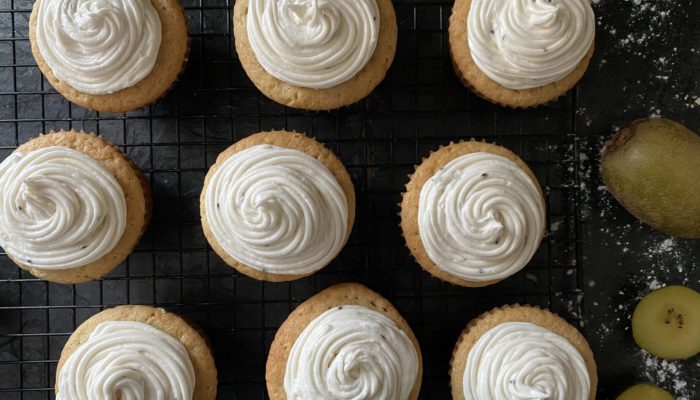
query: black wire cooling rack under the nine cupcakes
[{"left": 0, "top": 0, "right": 583, "bottom": 399}]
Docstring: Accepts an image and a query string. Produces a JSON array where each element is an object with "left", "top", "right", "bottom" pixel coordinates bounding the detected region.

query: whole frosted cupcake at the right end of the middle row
[{"left": 401, "top": 140, "right": 546, "bottom": 287}]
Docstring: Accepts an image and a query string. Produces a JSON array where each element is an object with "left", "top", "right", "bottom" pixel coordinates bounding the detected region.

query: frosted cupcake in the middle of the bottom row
[{"left": 265, "top": 283, "right": 423, "bottom": 400}]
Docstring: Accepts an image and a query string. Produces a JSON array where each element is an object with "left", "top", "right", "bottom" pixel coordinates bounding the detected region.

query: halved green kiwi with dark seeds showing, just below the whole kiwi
[{"left": 632, "top": 286, "right": 700, "bottom": 360}]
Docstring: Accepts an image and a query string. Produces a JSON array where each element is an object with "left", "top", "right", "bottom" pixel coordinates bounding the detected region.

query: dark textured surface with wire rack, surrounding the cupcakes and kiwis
[{"left": 0, "top": 0, "right": 700, "bottom": 400}]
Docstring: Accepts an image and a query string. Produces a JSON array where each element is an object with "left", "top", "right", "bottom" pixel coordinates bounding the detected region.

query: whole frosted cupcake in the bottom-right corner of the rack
[{"left": 450, "top": 305, "right": 598, "bottom": 400}]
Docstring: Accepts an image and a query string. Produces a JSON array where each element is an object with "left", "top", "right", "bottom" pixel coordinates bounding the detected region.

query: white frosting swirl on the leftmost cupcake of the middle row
[{"left": 0, "top": 146, "right": 126, "bottom": 270}]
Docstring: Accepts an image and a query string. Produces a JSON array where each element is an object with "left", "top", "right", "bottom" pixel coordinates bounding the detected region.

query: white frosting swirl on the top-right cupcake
[{"left": 467, "top": 0, "right": 595, "bottom": 89}]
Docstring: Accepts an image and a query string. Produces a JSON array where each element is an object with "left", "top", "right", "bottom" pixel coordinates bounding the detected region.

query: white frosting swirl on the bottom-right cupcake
[{"left": 462, "top": 322, "right": 591, "bottom": 400}]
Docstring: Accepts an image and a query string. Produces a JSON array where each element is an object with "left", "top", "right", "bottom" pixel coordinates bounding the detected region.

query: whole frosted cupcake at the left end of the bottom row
[{"left": 55, "top": 306, "right": 217, "bottom": 400}]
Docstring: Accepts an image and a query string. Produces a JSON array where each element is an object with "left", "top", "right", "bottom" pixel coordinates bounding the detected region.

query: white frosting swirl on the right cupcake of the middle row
[{"left": 418, "top": 152, "right": 545, "bottom": 281}]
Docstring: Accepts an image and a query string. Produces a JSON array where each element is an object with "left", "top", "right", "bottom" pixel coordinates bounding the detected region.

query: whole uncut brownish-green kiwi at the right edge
[{"left": 601, "top": 118, "right": 700, "bottom": 238}]
